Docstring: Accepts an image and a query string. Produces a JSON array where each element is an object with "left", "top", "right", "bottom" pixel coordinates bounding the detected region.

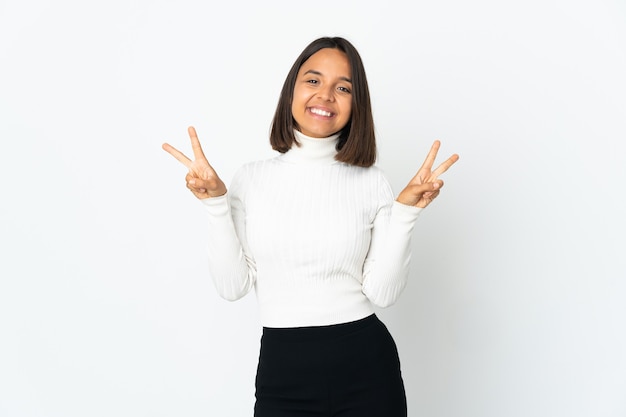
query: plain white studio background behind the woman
[{"left": 0, "top": 0, "right": 626, "bottom": 417}]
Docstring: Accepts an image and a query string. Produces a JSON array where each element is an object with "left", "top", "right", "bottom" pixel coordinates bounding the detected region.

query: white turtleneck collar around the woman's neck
[{"left": 280, "top": 130, "right": 339, "bottom": 165}]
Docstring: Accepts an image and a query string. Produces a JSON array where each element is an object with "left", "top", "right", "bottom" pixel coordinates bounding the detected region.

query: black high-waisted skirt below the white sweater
[{"left": 254, "top": 314, "right": 407, "bottom": 417}]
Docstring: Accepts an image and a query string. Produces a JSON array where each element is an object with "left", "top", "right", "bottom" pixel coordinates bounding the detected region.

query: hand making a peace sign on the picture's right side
[{"left": 397, "top": 140, "right": 459, "bottom": 208}]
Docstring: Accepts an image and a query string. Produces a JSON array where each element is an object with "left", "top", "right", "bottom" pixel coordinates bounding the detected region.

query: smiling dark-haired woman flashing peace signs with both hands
[{"left": 163, "top": 38, "right": 458, "bottom": 417}]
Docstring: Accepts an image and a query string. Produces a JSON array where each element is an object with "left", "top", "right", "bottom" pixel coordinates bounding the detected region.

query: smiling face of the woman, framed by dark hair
[{"left": 291, "top": 48, "right": 352, "bottom": 138}]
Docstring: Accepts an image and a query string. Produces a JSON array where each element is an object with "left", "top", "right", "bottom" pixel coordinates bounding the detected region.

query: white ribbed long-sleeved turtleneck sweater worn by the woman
[{"left": 202, "top": 132, "right": 421, "bottom": 328}]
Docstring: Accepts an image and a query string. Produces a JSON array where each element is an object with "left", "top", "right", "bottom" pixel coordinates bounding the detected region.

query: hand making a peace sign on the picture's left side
[{"left": 163, "top": 126, "right": 226, "bottom": 199}]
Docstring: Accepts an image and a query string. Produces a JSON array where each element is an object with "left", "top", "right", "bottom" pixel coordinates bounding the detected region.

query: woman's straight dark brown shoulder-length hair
[{"left": 270, "top": 37, "right": 376, "bottom": 167}]
